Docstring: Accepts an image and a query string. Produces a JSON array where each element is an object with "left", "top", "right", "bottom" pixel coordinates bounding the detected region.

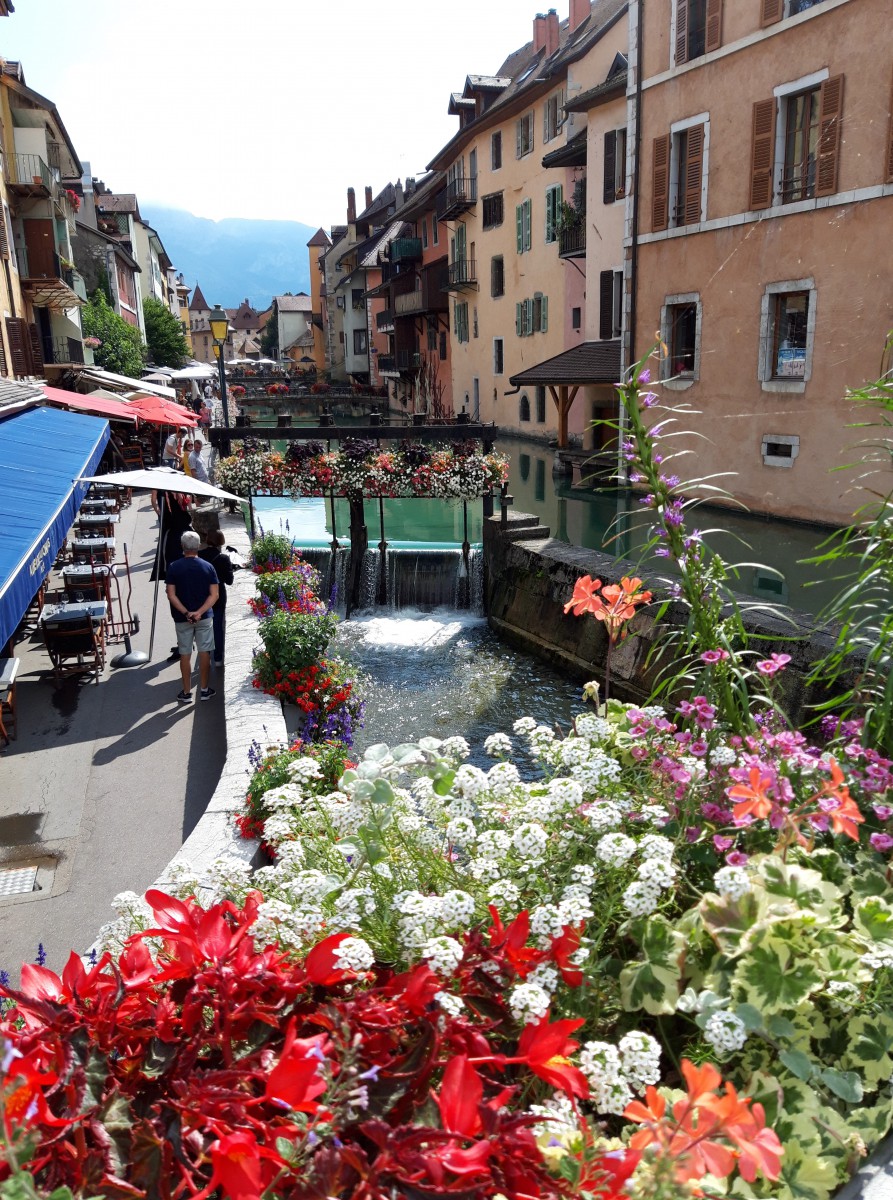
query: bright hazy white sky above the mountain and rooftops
[{"left": 0, "top": 0, "right": 537, "bottom": 228}]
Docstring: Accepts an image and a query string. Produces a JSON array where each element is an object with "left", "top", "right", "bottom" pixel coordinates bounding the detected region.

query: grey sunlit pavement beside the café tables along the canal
[{"left": 0, "top": 482, "right": 227, "bottom": 982}]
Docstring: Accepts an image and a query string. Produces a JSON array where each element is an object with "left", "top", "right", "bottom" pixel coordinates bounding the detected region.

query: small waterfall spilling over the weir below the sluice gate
[{"left": 352, "top": 546, "right": 484, "bottom": 613}]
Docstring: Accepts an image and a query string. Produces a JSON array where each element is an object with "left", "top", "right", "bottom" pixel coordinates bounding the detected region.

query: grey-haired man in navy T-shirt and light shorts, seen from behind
[{"left": 166, "top": 529, "right": 220, "bottom": 704}]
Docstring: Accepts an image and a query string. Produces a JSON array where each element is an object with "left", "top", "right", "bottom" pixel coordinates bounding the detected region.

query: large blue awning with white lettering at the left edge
[{"left": 0, "top": 408, "right": 108, "bottom": 648}]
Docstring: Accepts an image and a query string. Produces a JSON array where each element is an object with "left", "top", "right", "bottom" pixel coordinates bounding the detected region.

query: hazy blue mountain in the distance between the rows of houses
[{"left": 139, "top": 203, "right": 316, "bottom": 308}]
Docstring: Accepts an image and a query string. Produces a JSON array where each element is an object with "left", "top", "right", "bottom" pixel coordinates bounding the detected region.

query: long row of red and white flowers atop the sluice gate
[{"left": 217, "top": 439, "right": 508, "bottom": 499}]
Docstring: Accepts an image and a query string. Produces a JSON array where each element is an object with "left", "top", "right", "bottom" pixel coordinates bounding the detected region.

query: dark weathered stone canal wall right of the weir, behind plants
[{"left": 484, "top": 510, "right": 858, "bottom": 724}]
